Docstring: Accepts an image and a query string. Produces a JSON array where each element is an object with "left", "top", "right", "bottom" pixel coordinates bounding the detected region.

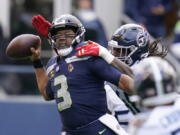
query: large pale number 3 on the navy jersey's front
[{"left": 54, "top": 75, "right": 72, "bottom": 111}]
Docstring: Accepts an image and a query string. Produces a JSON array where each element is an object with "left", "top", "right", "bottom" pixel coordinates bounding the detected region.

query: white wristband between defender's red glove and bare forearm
[{"left": 99, "top": 45, "right": 114, "bottom": 64}]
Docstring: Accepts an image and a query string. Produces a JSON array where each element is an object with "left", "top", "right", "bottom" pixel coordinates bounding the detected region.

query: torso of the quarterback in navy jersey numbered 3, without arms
[{"left": 47, "top": 52, "right": 107, "bottom": 129}]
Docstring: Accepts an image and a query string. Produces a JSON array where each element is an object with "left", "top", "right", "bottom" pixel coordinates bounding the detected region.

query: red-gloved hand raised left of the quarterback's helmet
[{"left": 32, "top": 15, "right": 52, "bottom": 38}]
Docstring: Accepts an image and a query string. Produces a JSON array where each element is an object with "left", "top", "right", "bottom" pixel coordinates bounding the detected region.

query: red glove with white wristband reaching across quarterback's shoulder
[{"left": 75, "top": 41, "right": 114, "bottom": 64}]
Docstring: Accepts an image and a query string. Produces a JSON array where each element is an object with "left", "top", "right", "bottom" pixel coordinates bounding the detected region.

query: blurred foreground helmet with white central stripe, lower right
[{"left": 134, "top": 57, "right": 177, "bottom": 108}]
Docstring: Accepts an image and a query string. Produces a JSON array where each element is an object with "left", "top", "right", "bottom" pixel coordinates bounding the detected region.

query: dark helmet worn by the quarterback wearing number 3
[{"left": 49, "top": 14, "right": 85, "bottom": 56}]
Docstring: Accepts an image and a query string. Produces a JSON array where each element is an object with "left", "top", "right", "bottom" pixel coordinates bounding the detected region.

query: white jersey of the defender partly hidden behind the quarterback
[{"left": 105, "top": 61, "right": 139, "bottom": 131}]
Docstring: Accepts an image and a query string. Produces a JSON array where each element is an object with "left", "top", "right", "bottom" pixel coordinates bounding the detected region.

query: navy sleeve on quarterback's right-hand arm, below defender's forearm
[{"left": 90, "top": 57, "right": 121, "bottom": 86}]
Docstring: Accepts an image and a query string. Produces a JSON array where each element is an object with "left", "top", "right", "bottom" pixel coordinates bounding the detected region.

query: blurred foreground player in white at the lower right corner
[{"left": 129, "top": 57, "right": 180, "bottom": 135}]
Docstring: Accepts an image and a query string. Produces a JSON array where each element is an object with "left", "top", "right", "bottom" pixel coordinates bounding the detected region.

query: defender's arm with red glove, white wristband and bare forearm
[{"left": 76, "top": 41, "right": 133, "bottom": 77}]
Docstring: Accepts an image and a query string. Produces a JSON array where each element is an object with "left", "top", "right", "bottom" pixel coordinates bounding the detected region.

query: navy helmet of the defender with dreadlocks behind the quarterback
[{"left": 108, "top": 24, "right": 150, "bottom": 66}]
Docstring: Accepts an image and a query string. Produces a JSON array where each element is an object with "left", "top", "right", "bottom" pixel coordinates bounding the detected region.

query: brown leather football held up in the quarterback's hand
[{"left": 6, "top": 34, "right": 41, "bottom": 59}]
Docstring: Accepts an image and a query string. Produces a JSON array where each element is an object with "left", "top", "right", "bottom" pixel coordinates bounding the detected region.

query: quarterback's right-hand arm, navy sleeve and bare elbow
[{"left": 89, "top": 58, "right": 134, "bottom": 94}]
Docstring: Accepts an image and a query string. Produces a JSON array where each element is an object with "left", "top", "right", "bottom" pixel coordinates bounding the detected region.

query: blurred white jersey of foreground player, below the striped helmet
[{"left": 128, "top": 105, "right": 180, "bottom": 135}]
